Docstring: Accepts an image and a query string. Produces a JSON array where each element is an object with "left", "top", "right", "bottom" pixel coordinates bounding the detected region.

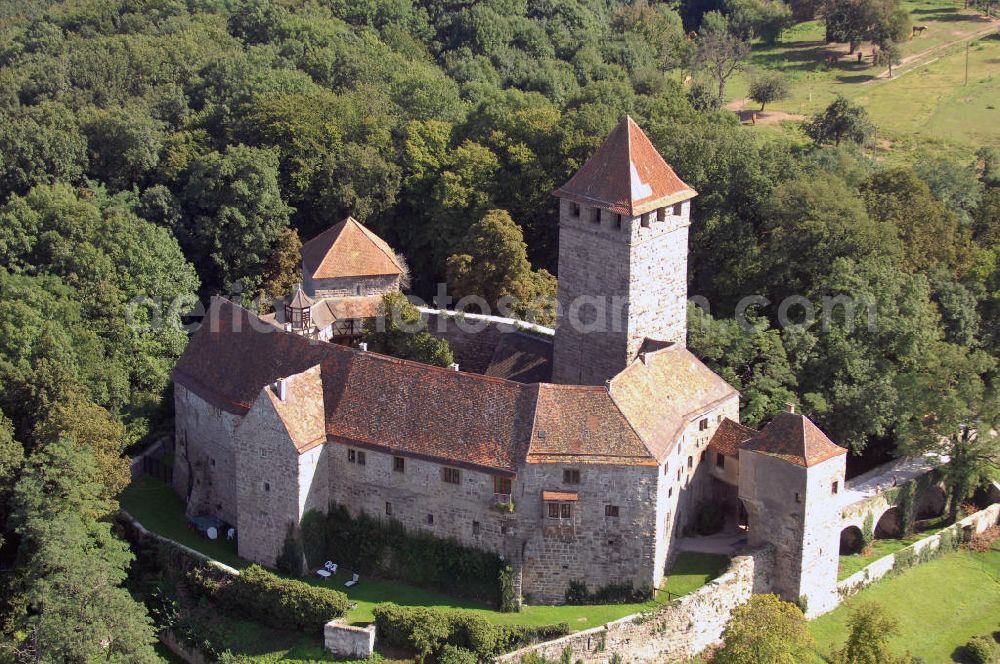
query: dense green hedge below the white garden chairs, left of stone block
[{"left": 188, "top": 565, "right": 350, "bottom": 634}]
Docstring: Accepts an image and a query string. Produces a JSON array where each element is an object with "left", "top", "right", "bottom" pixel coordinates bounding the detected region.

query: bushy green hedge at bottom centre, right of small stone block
[{"left": 372, "top": 603, "right": 569, "bottom": 660}]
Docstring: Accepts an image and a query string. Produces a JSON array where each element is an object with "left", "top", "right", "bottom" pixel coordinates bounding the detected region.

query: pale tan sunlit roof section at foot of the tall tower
[{"left": 609, "top": 346, "right": 737, "bottom": 463}]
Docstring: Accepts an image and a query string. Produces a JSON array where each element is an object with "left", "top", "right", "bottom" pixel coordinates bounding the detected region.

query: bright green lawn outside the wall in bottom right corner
[{"left": 810, "top": 542, "right": 1000, "bottom": 664}]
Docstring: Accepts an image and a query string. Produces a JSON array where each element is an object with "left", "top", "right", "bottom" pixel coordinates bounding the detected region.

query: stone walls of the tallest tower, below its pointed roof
[{"left": 553, "top": 200, "right": 690, "bottom": 385}]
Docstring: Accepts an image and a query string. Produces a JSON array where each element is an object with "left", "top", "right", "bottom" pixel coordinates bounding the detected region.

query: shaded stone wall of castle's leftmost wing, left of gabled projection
[{"left": 174, "top": 382, "right": 242, "bottom": 524}]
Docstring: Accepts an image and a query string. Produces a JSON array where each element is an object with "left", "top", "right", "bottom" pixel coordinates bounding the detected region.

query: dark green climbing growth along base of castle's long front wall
[{"left": 301, "top": 504, "right": 500, "bottom": 606}]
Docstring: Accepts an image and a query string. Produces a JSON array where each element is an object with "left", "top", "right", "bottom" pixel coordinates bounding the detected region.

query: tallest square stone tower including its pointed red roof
[{"left": 552, "top": 116, "right": 697, "bottom": 385}]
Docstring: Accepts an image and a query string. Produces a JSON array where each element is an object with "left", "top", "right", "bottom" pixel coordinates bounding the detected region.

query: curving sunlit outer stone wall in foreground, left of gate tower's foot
[{"left": 497, "top": 550, "right": 771, "bottom": 664}]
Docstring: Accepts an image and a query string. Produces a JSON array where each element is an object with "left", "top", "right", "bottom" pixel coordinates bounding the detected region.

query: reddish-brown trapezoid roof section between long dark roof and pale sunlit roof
[{"left": 527, "top": 384, "right": 656, "bottom": 465}]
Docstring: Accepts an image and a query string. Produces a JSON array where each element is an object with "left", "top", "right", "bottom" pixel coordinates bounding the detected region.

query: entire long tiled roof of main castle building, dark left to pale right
[{"left": 174, "top": 298, "right": 736, "bottom": 474}]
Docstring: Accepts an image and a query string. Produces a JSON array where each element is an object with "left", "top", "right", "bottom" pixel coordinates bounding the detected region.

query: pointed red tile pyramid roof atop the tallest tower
[{"left": 554, "top": 115, "right": 698, "bottom": 216}]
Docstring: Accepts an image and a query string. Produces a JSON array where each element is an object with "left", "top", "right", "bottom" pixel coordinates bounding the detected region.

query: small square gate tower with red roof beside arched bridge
[{"left": 739, "top": 406, "right": 847, "bottom": 618}]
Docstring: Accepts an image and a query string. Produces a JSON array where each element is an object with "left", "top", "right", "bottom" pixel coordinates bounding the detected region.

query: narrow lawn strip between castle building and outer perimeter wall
[{"left": 121, "top": 475, "right": 729, "bottom": 631}]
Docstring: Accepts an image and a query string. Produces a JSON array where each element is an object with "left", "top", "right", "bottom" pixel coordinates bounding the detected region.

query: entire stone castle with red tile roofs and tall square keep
[{"left": 174, "top": 117, "right": 846, "bottom": 615}]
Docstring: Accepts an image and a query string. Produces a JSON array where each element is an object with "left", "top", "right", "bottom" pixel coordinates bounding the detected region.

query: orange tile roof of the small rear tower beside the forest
[{"left": 301, "top": 217, "right": 402, "bottom": 279}]
